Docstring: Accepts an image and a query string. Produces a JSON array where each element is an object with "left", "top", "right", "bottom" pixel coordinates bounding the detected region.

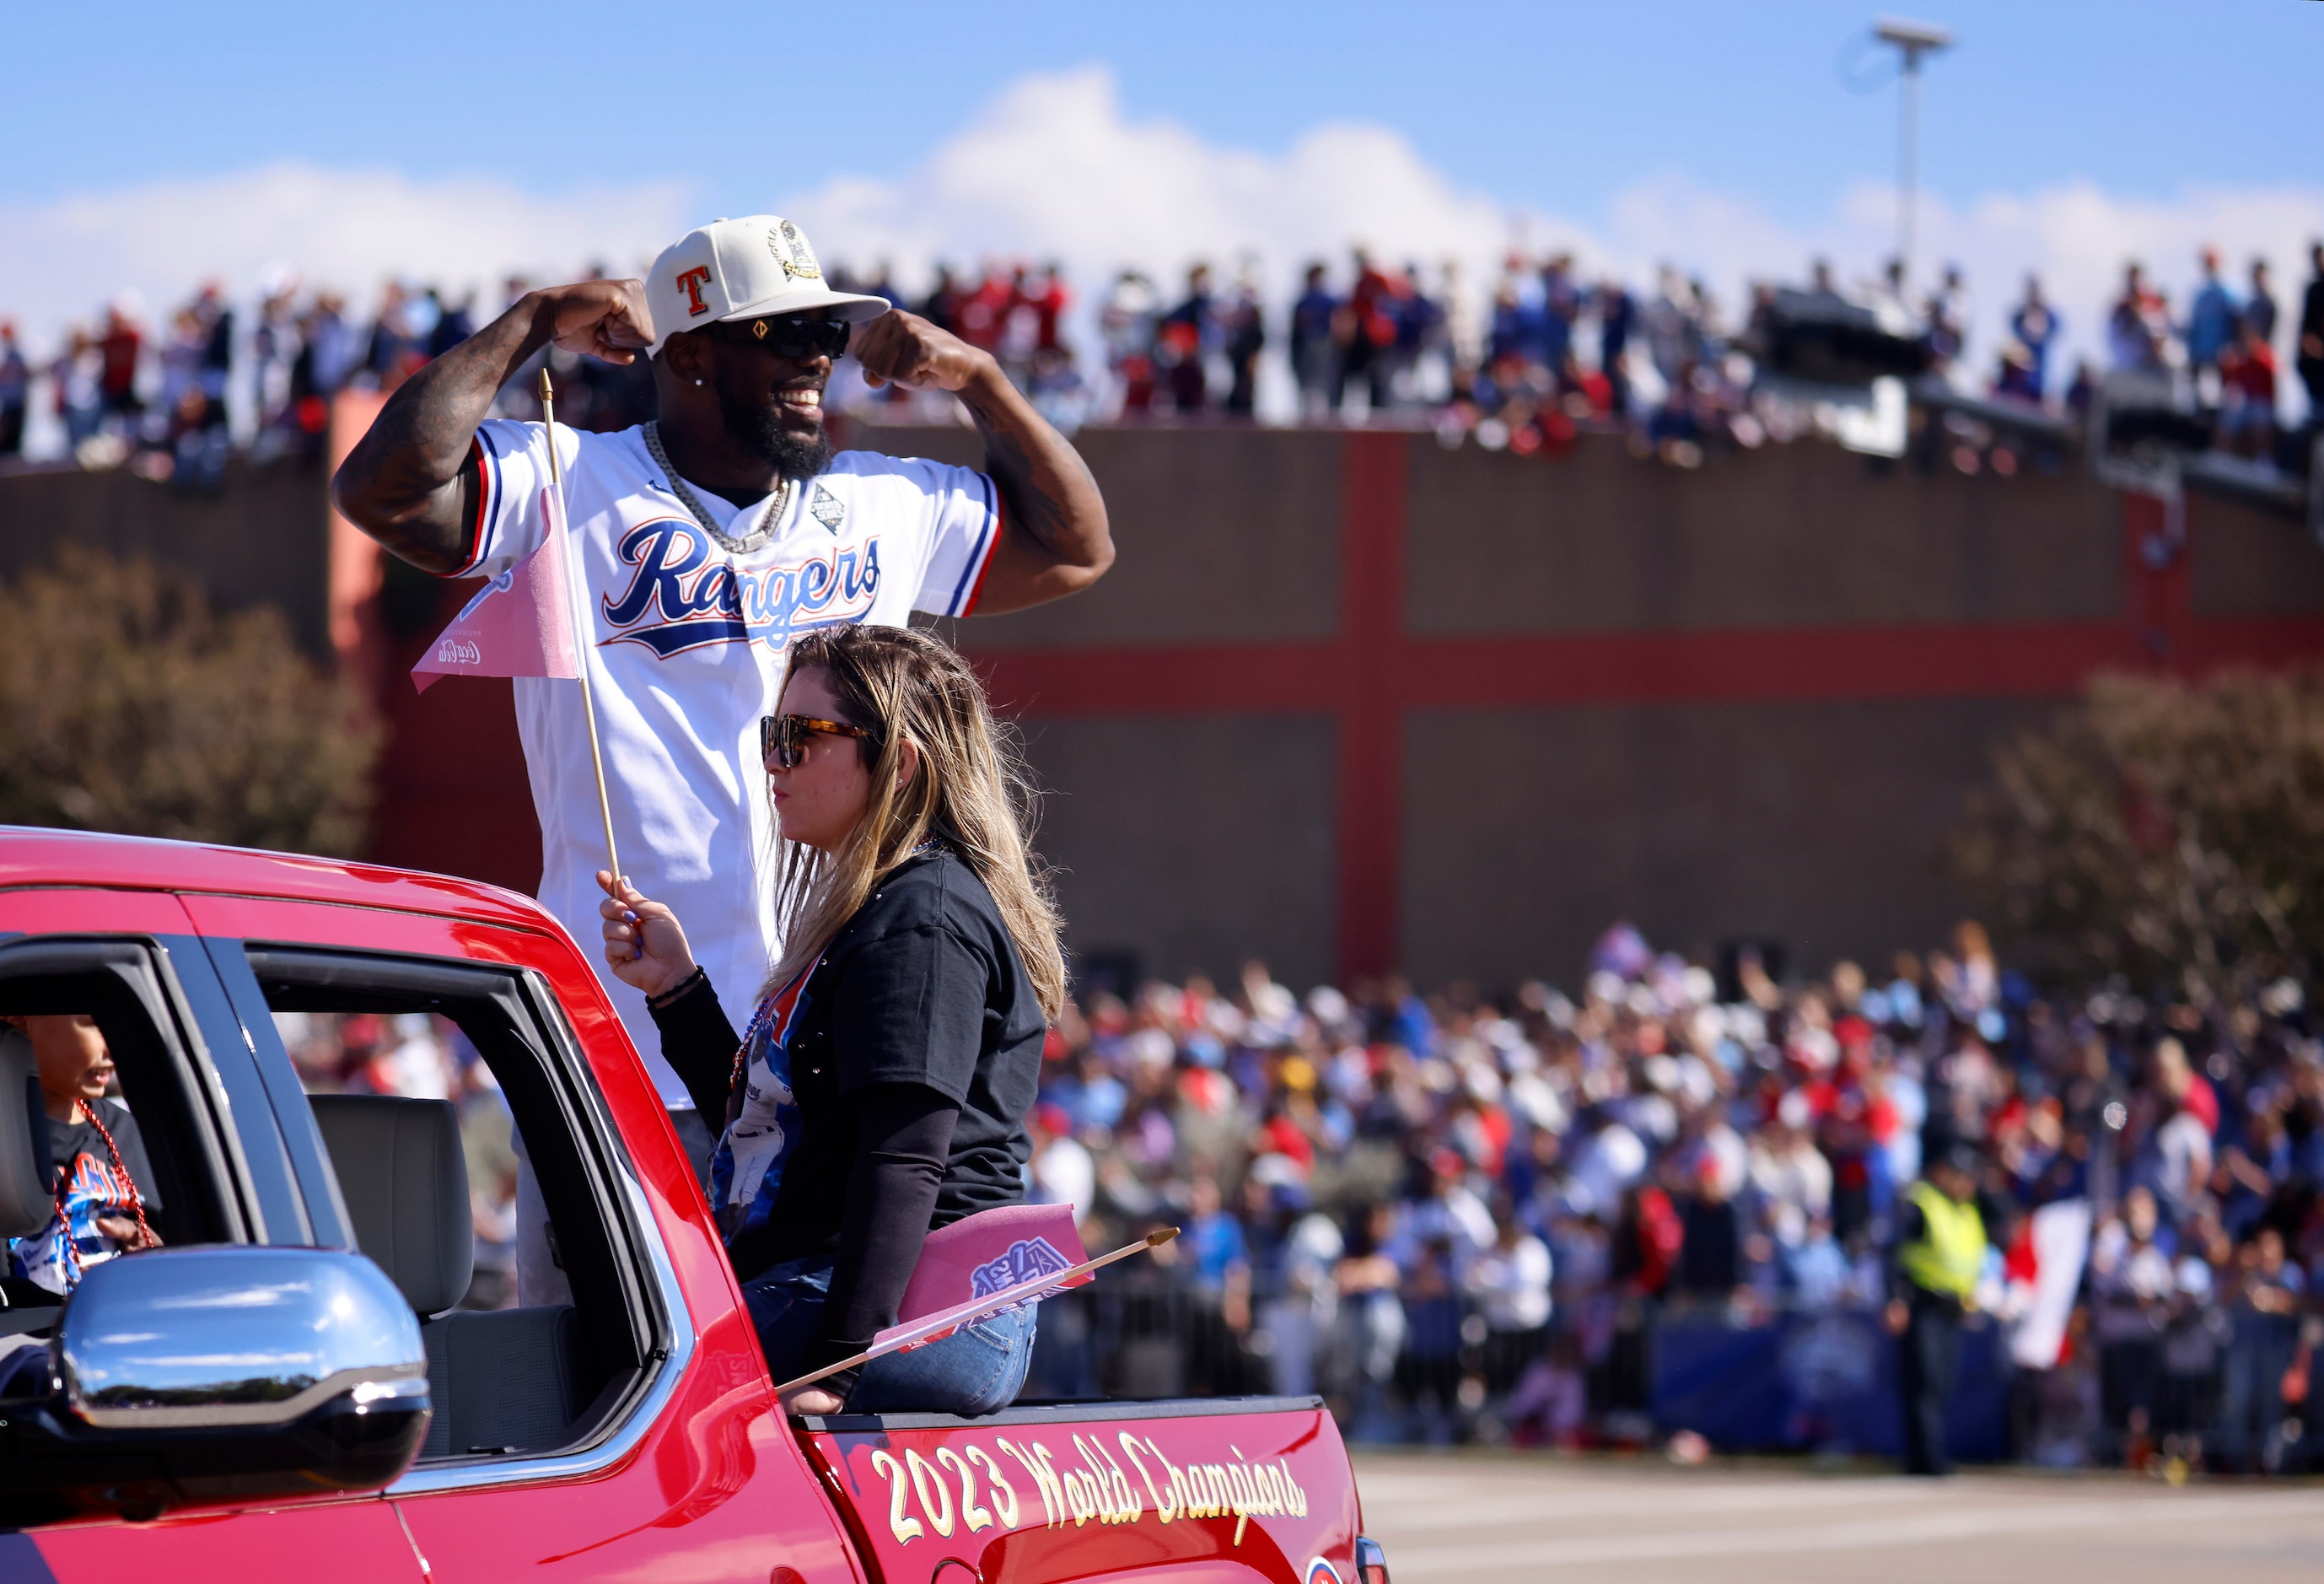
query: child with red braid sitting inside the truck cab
[{"left": 7, "top": 1014, "right": 160, "bottom": 1293}]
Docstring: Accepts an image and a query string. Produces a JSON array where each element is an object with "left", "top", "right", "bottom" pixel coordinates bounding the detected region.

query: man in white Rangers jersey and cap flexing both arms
[{"left": 332, "top": 214, "right": 1113, "bottom": 1284}]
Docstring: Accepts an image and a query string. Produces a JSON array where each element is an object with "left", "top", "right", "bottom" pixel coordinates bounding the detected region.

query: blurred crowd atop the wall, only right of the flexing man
[{"left": 855, "top": 246, "right": 2324, "bottom": 470}]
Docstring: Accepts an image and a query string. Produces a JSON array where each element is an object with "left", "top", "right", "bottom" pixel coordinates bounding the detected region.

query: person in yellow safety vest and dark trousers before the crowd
[{"left": 1887, "top": 1145, "right": 1985, "bottom": 1474}]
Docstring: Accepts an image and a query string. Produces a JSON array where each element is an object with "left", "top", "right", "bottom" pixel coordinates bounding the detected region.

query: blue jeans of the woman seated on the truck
[{"left": 741, "top": 1258, "right": 1034, "bottom": 1416}]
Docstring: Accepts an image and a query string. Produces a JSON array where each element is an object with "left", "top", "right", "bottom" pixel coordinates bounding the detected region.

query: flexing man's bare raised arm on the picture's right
[{"left": 855, "top": 312, "right": 1113, "bottom": 617}]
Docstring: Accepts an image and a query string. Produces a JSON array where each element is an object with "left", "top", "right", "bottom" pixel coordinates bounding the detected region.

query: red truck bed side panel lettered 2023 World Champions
[{"left": 797, "top": 1398, "right": 1358, "bottom": 1584}]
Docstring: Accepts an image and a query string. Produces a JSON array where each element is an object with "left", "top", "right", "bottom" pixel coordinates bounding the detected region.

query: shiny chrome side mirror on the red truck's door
[{"left": 0, "top": 1244, "right": 430, "bottom": 1526}]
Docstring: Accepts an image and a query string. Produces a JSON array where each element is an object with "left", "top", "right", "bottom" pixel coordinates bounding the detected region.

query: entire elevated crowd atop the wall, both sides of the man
[{"left": 0, "top": 245, "right": 2324, "bottom": 488}]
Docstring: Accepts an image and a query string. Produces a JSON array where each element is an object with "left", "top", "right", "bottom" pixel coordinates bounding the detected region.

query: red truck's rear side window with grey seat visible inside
[{"left": 249, "top": 946, "right": 660, "bottom": 1463}]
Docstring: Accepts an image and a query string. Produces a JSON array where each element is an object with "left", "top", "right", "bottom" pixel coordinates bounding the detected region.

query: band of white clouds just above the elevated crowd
[{"left": 0, "top": 67, "right": 2324, "bottom": 412}]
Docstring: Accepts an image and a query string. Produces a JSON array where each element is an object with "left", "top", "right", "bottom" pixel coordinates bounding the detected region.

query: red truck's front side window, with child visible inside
[{"left": 0, "top": 940, "right": 246, "bottom": 1382}]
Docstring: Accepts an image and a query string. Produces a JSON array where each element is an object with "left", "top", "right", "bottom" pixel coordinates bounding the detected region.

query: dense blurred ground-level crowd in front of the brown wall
[{"left": 281, "top": 926, "right": 2324, "bottom": 1470}]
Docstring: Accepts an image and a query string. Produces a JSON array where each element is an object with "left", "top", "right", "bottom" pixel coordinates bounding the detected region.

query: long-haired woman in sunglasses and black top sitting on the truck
[{"left": 597, "top": 626, "right": 1064, "bottom": 1414}]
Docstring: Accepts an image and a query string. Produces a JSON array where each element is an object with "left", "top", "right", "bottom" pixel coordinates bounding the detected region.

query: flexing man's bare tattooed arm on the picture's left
[{"left": 330, "top": 282, "right": 653, "bottom": 574}]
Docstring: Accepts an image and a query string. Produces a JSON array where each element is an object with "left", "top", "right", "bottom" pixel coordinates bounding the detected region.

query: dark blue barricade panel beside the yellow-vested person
[{"left": 1650, "top": 1310, "right": 2010, "bottom": 1463}]
